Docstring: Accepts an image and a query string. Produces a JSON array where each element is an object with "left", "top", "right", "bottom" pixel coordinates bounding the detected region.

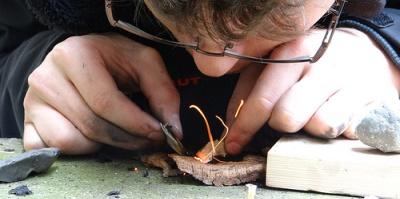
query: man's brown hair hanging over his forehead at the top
[{"left": 145, "top": 0, "right": 305, "bottom": 41}]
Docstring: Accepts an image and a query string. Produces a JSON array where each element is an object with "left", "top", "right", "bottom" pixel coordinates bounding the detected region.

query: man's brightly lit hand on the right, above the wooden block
[{"left": 226, "top": 29, "right": 400, "bottom": 154}]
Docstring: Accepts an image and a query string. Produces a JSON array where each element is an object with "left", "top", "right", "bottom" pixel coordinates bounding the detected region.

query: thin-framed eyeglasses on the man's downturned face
[{"left": 105, "top": 0, "right": 346, "bottom": 64}]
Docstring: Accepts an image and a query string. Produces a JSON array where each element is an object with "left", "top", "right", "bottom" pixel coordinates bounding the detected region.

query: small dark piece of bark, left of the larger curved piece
[{"left": 140, "top": 152, "right": 181, "bottom": 177}]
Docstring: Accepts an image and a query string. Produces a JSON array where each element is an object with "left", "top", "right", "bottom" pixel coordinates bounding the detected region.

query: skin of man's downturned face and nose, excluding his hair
[{"left": 144, "top": 0, "right": 334, "bottom": 77}]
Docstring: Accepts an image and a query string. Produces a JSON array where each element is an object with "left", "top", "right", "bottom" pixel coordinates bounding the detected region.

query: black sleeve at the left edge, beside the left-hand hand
[{"left": 0, "top": 31, "right": 68, "bottom": 137}]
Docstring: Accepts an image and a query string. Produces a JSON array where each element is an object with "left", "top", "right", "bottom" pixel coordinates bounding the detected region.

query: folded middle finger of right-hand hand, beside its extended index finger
[{"left": 269, "top": 63, "right": 342, "bottom": 133}]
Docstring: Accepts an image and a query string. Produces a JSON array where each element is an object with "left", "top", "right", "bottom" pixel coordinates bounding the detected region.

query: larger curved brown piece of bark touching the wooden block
[{"left": 169, "top": 154, "right": 266, "bottom": 186}]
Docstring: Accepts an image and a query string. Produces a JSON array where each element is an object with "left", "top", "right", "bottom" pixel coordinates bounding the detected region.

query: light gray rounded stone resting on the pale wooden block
[{"left": 355, "top": 103, "right": 400, "bottom": 153}]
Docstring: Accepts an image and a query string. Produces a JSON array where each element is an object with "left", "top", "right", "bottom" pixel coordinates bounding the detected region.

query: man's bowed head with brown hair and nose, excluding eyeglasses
[{"left": 144, "top": 0, "right": 335, "bottom": 76}]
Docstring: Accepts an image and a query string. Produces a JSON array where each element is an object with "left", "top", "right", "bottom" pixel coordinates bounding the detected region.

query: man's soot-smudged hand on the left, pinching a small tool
[{"left": 23, "top": 34, "right": 182, "bottom": 154}]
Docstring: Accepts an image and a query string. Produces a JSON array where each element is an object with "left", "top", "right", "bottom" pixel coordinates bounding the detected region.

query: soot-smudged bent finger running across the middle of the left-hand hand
[{"left": 27, "top": 60, "right": 155, "bottom": 150}]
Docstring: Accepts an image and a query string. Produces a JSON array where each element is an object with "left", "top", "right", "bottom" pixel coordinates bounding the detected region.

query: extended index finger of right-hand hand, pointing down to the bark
[{"left": 226, "top": 58, "right": 304, "bottom": 154}]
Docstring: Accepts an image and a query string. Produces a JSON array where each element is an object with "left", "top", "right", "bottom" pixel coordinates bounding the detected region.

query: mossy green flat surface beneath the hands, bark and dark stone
[{"left": 0, "top": 139, "right": 356, "bottom": 199}]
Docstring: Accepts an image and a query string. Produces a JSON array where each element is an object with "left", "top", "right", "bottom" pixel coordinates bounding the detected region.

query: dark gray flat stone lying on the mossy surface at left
[{"left": 0, "top": 148, "right": 60, "bottom": 182}]
